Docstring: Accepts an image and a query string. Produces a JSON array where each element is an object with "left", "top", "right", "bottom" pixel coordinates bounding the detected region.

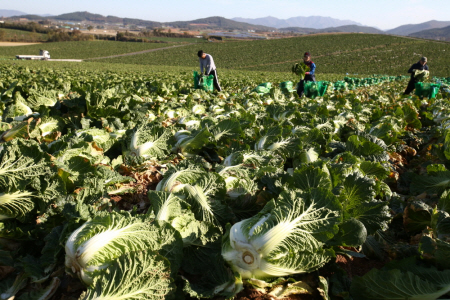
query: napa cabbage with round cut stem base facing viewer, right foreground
[{"left": 222, "top": 189, "right": 342, "bottom": 279}]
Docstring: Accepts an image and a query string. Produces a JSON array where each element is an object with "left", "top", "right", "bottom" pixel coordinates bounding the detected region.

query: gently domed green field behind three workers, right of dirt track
[{"left": 95, "top": 34, "right": 450, "bottom": 76}]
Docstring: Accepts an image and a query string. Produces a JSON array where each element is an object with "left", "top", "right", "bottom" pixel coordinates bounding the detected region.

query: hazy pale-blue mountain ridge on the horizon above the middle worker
[{"left": 232, "top": 16, "right": 361, "bottom": 29}]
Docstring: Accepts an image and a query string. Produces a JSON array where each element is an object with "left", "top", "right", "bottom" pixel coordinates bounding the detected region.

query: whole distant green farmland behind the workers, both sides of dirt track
[{"left": 0, "top": 34, "right": 450, "bottom": 77}]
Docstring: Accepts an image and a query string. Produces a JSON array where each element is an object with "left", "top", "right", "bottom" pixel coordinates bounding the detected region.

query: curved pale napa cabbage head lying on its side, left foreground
[{"left": 65, "top": 213, "right": 183, "bottom": 285}]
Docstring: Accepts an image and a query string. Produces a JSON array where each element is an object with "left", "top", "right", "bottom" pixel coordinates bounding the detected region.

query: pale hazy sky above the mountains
[{"left": 0, "top": 0, "right": 450, "bottom": 29}]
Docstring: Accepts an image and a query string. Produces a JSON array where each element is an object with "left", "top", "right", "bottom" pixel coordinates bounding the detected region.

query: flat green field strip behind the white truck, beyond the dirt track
[{"left": 0, "top": 41, "right": 176, "bottom": 59}]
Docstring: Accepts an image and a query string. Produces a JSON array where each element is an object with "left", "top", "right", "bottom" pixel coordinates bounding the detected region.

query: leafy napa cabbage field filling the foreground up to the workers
[{"left": 0, "top": 63, "right": 450, "bottom": 300}]
